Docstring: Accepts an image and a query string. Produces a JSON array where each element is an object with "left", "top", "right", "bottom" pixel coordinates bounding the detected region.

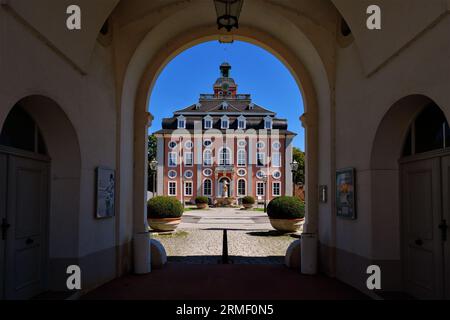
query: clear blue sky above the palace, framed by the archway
[{"left": 149, "top": 41, "right": 304, "bottom": 150}]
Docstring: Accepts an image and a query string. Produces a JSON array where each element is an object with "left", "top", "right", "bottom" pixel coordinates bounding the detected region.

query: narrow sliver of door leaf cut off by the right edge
[{"left": 440, "top": 156, "right": 450, "bottom": 299}]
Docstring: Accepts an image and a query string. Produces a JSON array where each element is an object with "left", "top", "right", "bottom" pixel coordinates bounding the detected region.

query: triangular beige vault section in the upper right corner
[{"left": 331, "top": 0, "right": 450, "bottom": 75}]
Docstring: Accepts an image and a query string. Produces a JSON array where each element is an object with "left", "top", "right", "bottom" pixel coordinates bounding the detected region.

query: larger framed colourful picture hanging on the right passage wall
[{"left": 336, "top": 168, "right": 356, "bottom": 220}]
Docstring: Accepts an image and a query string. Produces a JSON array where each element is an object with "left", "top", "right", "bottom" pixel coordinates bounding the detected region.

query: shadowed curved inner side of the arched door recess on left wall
[{"left": 1, "top": 95, "right": 81, "bottom": 298}]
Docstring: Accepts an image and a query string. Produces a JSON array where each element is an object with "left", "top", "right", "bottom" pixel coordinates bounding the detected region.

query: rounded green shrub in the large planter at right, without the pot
[{"left": 267, "top": 196, "right": 305, "bottom": 219}]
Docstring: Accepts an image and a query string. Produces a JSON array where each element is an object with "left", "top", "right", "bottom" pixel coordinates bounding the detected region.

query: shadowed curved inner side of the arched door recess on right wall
[{"left": 370, "top": 94, "right": 448, "bottom": 291}]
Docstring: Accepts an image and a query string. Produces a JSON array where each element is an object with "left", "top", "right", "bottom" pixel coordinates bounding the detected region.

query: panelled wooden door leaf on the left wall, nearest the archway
[{"left": 5, "top": 156, "right": 48, "bottom": 299}]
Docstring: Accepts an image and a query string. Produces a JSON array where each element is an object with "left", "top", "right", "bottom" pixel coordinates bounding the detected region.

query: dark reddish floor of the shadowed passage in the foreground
[{"left": 82, "top": 263, "right": 369, "bottom": 300}]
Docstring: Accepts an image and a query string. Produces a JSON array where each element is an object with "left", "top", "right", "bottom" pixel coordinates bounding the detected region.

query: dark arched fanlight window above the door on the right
[{"left": 402, "top": 103, "right": 450, "bottom": 157}]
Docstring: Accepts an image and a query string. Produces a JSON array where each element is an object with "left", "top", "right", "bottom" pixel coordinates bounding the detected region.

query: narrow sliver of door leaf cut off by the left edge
[{"left": 0, "top": 153, "right": 8, "bottom": 299}]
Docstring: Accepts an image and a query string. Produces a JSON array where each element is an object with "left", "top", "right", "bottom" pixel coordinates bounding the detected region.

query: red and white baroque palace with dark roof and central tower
[{"left": 155, "top": 63, "right": 296, "bottom": 203}]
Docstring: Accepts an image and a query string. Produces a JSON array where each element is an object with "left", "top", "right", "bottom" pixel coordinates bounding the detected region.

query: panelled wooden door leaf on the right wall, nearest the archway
[{"left": 402, "top": 158, "right": 444, "bottom": 299}]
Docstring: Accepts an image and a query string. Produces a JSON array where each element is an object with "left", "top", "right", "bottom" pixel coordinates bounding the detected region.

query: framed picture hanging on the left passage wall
[{"left": 95, "top": 167, "right": 116, "bottom": 219}]
